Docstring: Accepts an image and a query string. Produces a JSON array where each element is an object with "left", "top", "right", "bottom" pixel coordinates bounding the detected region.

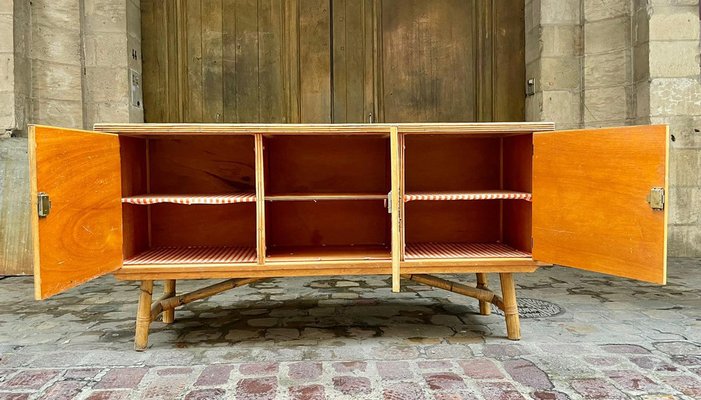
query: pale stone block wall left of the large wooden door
[{"left": 0, "top": 0, "right": 143, "bottom": 274}]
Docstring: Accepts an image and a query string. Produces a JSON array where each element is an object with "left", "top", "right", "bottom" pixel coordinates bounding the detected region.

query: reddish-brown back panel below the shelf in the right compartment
[{"left": 405, "top": 200, "right": 500, "bottom": 243}]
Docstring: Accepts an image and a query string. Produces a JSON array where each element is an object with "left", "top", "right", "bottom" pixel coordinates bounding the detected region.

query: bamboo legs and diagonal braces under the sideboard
[{"left": 134, "top": 273, "right": 521, "bottom": 351}]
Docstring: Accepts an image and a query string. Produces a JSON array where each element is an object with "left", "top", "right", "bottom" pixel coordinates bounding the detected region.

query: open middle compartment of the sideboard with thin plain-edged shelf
[{"left": 263, "top": 135, "right": 391, "bottom": 262}]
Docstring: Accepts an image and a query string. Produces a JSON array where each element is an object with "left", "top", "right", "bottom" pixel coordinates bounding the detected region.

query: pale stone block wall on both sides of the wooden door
[{"left": 0, "top": 0, "right": 701, "bottom": 273}]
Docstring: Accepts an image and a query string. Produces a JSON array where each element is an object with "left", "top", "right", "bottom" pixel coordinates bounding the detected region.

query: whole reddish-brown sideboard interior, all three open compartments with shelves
[{"left": 120, "top": 130, "right": 532, "bottom": 265}]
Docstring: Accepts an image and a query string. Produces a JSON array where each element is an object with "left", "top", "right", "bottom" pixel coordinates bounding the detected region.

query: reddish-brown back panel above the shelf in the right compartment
[{"left": 404, "top": 135, "right": 501, "bottom": 192}]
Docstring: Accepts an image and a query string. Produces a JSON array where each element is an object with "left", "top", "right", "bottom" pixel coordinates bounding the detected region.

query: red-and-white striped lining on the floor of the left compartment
[{"left": 124, "top": 246, "right": 257, "bottom": 265}]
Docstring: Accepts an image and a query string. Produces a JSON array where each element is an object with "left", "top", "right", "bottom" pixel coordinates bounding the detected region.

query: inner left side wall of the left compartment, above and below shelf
[{"left": 119, "top": 136, "right": 149, "bottom": 258}]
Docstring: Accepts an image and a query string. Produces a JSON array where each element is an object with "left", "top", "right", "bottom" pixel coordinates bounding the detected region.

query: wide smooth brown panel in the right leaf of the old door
[{"left": 380, "top": 0, "right": 476, "bottom": 122}]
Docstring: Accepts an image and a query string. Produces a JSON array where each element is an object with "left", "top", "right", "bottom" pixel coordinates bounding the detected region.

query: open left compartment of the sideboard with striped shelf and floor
[{"left": 120, "top": 135, "right": 257, "bottom": 264}]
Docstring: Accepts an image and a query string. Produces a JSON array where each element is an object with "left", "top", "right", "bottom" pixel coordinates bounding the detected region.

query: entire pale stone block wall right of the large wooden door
[{"left": 526, "top": 0, "right": 701, "bottom": 257}]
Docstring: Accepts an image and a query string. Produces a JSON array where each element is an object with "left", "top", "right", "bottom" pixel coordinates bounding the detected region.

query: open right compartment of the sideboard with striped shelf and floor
[{"left": 402, "top": 134, "right": 532, "bottom": 260}]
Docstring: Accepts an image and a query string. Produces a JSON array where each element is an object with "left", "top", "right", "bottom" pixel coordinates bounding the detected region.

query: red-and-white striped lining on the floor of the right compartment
[{"left": 404, "top": 243, "right": 531, "bottom": 260}]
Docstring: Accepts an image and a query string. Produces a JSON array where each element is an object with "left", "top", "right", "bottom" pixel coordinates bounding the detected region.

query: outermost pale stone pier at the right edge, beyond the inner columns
[{"left": 645, "top": 0, "right": 701, "bottom": 257}]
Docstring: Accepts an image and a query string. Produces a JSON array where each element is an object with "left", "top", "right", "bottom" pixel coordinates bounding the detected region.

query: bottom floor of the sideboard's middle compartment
[{"left": 266, "top": 245, "right": 392, "bottom": 262}]
